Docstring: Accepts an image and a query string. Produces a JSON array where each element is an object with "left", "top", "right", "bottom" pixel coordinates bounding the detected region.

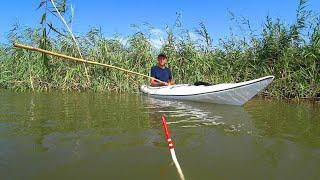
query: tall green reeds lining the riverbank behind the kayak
[{"left": 0, "top": 0, "right": 320, "bottom": 98}]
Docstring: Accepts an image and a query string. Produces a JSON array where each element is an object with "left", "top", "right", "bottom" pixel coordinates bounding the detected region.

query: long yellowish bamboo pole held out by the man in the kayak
[{"left": 13, "top": 43, "right": 165, "bottom": 83}]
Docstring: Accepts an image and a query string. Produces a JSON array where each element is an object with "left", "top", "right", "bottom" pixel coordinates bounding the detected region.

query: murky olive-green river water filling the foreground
[{"left": 0, "top": 90, "right": 320, "bottom": 180}]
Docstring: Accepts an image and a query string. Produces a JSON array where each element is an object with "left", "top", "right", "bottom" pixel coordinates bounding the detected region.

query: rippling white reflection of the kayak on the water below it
[{"left": 145, "top": 98, "right": 255, "bottom": 134}]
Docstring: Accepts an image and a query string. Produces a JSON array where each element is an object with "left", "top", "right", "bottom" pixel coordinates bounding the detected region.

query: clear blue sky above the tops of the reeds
[{"left": 0, "top": 0, "right": 320, "bottom": 44}]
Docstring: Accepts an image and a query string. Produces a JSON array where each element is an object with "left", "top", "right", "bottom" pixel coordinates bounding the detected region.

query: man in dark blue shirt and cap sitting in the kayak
[{"left": 150, "top": 53, "right": 173, "bottom": 86}]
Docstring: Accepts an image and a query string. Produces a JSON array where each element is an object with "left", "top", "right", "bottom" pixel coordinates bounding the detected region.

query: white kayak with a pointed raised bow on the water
[{"left": 140, "top": 76, "right": 274, "bottom": 105}]
